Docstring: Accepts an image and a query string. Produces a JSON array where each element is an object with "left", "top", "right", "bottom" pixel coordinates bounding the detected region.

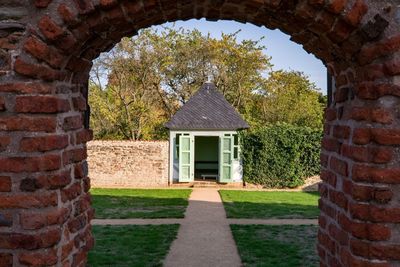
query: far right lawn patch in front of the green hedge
[{"left": 219, "top": 190, "right": 319, "bottom": 219}]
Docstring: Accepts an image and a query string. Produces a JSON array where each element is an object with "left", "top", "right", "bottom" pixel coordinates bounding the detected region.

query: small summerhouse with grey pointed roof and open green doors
[{"left": 165, "top": 83, "right": 249, "bottom": 183}]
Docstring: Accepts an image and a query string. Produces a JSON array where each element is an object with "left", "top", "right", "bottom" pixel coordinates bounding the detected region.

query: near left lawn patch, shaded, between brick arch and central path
[{"left": 88, "top": 224, "right": 179, "bottom": 267}]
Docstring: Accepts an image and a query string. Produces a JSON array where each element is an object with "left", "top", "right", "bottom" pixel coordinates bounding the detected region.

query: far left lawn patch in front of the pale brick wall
[{"left": 91, "top": 189, "right": 191, "bottom": 219}]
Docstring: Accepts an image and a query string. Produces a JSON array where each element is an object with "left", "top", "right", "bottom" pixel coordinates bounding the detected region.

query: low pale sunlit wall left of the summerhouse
[{"left": 87, "top": 141, "right": 168, "bottom": 188}]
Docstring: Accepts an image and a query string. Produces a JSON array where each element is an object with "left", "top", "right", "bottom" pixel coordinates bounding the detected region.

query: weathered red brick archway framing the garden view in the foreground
[{"left": 0, "top": 0, "right": 400, "bottom": 266}]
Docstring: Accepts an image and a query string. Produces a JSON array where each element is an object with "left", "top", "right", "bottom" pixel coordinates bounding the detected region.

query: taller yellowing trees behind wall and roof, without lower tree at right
[{"left": 89, "top": 28, "right": 271, "bottom": 140}]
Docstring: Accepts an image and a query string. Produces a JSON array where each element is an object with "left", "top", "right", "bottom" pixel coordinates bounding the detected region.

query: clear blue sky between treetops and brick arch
[{"left": 156, "top": 19, "right": 327, "bottom": 94}]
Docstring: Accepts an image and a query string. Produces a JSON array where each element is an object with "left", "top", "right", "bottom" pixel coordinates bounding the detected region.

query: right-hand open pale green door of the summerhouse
[{"left": 219, "top": 135, "right": 233, "bottom": 183}]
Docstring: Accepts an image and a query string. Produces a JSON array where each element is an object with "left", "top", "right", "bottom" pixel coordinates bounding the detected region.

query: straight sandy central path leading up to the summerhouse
[{"left": 164, "top": 188, "right": 242, "bottom": 267}]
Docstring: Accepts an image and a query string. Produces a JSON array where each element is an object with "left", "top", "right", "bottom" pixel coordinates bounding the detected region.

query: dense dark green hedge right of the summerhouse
[{"left": 241, "top": 123, "right": 323, "bottom": 188}]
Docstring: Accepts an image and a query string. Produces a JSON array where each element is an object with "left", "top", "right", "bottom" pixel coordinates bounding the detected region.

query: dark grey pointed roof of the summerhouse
[{"left": 165, "top": 83, "right": 249, "bottom": 130}]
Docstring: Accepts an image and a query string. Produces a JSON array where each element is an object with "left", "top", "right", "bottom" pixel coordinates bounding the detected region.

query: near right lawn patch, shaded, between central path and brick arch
[{"left": 231, "top": 225, "right": 319, "bottom": 267}]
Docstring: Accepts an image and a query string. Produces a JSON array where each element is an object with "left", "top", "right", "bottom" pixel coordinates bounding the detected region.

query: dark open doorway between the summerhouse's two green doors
[{"left": 194, "top": 136, "right": 219, "bottom": 181}]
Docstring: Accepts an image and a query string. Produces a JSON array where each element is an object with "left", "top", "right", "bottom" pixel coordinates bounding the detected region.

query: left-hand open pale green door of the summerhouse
[{"left": 179, "top": 134, "right": 194, "bottom": 182}]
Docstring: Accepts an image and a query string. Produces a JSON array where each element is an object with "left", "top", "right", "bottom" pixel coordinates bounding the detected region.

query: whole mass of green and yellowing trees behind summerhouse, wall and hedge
[{"left": 89, "top": 27, "right": 325, "bottom": 140}]
